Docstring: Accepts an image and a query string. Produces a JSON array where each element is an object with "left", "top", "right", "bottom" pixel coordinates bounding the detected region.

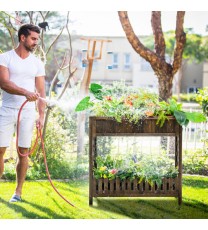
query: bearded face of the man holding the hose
[{"left": 21, "top": 31, "right": 39, "bottom": 52}]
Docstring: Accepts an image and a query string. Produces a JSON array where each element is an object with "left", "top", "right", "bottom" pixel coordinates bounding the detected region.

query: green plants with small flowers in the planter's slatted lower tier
[{"left": 94, "top": 154, "right": 178, "bottom": 185}]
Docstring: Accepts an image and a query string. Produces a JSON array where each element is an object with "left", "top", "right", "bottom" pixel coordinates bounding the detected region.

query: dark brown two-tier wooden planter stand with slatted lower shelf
[{"left": 89, "top": 116, "right": 182, "bottom": 205}]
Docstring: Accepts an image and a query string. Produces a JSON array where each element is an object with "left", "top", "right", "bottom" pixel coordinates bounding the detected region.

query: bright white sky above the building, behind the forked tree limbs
[{"left": 70, "top": 11, "right": 208, "bottom": 36}]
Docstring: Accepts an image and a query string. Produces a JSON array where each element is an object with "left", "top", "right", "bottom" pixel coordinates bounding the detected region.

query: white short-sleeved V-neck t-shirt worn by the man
[{"left": 0, "top": 50, "right": 45, "bottom": 109}]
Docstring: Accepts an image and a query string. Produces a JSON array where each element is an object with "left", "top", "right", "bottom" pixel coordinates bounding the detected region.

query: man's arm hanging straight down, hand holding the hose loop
[{"left": 35, "top": 76, "right": 46, "bottom": 128}]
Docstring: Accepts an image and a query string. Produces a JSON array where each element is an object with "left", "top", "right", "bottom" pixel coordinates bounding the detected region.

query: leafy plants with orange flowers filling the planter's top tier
[{"left": 75, "top": 83, "right": 206, "bottom": 126}]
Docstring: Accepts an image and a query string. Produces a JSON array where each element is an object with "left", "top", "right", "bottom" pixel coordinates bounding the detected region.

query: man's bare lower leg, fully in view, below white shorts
[{"left": 15, "top": 148, "right": 29, "bottom": 196}]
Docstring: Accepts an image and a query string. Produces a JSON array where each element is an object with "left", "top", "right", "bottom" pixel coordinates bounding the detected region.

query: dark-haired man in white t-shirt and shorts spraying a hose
[{"left": 0, "top": 24, "right": 45, "bottom": 202}]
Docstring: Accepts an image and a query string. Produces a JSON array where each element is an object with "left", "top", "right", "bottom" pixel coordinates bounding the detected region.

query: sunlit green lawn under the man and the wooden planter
[{"left": 0, "top": 175, "right": 208, "bottom": 219}]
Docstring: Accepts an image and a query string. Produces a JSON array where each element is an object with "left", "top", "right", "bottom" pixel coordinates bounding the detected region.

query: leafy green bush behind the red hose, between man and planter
[{"left": 27, "top": 110, "right": 88, "bottom": 179}]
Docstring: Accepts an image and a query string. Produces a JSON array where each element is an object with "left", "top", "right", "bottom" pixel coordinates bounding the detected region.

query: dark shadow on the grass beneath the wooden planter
[{"left": 92, "top": 198, "right": 208, "bottom": 219}]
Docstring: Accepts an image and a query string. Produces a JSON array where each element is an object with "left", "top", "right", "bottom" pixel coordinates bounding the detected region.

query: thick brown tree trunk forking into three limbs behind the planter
[{"left": 118, "top": 11, "right": 186, "bottom": 101}]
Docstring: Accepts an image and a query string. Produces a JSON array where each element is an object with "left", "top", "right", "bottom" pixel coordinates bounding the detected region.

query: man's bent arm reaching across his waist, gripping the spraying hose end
[{"left": 0, "top": 65, "right": 39, "bottom": 101}]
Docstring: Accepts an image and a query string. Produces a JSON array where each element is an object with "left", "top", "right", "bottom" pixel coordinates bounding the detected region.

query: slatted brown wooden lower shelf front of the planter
[{"left": 92, "top": 177, "right": 179, "bottom": 197}]
